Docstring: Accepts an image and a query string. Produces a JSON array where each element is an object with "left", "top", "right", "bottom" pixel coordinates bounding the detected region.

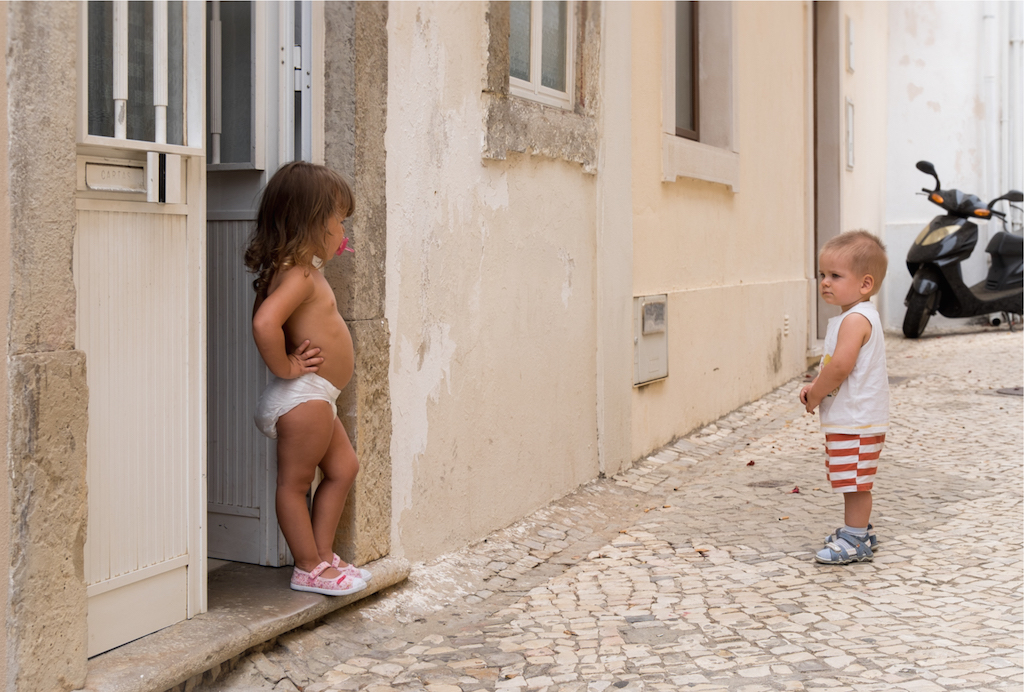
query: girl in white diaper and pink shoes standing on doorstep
[{"left": 245, "top": 161, "right": 371, "bottom": 596}]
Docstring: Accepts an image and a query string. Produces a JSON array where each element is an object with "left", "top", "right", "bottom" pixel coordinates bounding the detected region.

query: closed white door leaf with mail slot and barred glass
[{"left": 74, "top": 0, "right": 206, "bottom": 656}]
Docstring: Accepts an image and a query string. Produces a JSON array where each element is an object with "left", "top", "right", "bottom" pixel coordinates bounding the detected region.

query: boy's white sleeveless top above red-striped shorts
[{"left": 818, "top": 301, "right": 889, "bottom": 435}]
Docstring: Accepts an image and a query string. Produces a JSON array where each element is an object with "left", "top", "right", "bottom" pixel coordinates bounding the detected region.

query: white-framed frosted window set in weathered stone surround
[{"left": 509, "top": 0, "right": 573, "bottom": 109}]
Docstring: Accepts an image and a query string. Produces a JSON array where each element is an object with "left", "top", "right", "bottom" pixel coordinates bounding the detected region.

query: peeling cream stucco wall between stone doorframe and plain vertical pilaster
[{"left": 385, "top": 3, "right": 598, "bottom": 559}]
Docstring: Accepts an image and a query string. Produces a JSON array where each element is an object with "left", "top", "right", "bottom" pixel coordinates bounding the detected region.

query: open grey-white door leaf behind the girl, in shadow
[{"left": 207, "top": 0, "right": 324, "bottom": 566}]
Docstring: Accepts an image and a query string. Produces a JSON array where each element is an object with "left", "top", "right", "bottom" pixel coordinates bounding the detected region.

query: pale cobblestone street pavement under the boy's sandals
[{"left": 196, "top": 328, "right": 1024, "bottom": 692}]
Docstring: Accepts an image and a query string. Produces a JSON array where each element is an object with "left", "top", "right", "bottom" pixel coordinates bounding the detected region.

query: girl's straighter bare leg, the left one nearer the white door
[{"left": 276, "top": 401, "right": 340, "bottom": 578}]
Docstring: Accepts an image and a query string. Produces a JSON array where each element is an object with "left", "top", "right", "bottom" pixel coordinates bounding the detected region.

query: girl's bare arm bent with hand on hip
[{"left": 253, "top": 267, "right": 324, "bottom": 380}]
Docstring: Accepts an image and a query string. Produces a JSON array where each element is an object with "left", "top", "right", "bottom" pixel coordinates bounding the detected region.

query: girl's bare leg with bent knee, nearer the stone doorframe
[{"left": 312, "top": 418, "right": 359, "bottom": 562}]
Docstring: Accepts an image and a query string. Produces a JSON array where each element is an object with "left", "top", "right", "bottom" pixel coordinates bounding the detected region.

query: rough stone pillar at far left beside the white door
[{"left": 0, "top": 2, "right": 88, "bottom": 691}]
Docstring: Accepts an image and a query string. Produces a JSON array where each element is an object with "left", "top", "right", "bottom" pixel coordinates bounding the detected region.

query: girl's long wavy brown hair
[{"left": 245, "top": 161, "right": 355, "bottom": 294}]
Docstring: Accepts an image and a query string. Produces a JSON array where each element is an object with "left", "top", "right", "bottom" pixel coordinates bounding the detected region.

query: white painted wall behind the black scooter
[{"left": 881, "top": 2, "right": 1021, "bottom": 330}]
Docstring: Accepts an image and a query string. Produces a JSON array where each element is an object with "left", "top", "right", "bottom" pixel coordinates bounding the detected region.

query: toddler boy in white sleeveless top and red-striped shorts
[{"left": 800, "top": 230, "right": 889, "bottom": 565}]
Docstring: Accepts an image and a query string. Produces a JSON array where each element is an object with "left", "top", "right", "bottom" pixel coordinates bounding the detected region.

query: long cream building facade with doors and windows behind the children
[{"left": 0, "top": 0, "right": 913, "bottom": 690}]
